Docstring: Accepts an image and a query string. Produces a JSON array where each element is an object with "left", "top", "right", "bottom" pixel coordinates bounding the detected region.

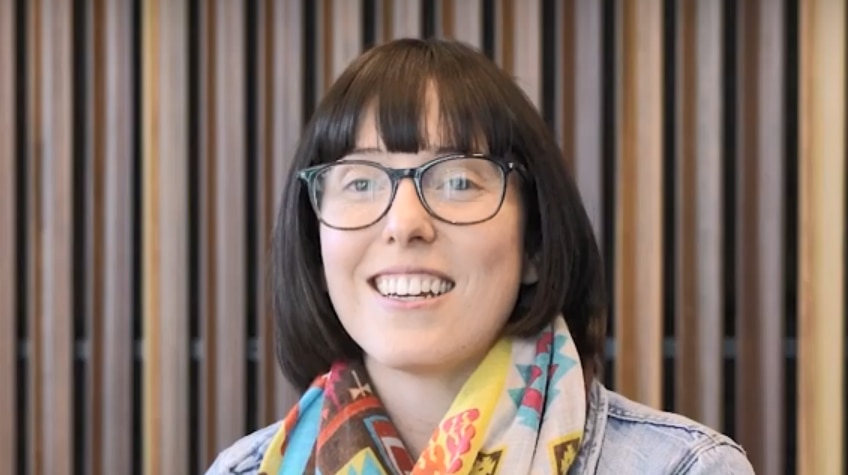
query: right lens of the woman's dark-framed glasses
[{"left": 421, "top": 157, "right": 506, "bottom": 224}]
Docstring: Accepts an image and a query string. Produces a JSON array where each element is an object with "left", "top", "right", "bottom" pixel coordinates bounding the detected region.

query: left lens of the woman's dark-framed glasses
[{"left": 314, "top": 162, "right": 392, "bottom": 228}]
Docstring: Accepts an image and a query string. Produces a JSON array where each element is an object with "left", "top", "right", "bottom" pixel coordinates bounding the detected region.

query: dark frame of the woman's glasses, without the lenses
[{"left": 297, "top": 154, "right": 527, "bottom": 231}]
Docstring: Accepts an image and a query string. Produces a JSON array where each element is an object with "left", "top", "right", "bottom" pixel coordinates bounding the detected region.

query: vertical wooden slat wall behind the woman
[{"left": 0, "top": 0, "right": 848, "bottom": 475}]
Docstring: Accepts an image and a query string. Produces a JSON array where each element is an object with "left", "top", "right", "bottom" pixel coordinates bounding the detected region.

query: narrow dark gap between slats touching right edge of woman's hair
[{"left": 601, "top": 0, "right": 617, "bottom": 388}]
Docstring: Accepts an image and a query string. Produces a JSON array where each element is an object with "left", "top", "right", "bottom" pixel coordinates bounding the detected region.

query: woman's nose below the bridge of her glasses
[{"left": 383, "top": 179, "right": 436, "bottom": 245}]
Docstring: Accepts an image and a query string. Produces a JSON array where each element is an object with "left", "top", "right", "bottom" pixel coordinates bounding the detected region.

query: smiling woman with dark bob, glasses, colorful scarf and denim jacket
[{"left": 208, "top": 40, "right": 753, "bottom": 475}]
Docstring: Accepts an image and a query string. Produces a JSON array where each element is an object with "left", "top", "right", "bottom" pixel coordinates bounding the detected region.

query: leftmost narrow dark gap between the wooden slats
[{"left": 13, "top": 0, "right": 31, "bottom": 475}]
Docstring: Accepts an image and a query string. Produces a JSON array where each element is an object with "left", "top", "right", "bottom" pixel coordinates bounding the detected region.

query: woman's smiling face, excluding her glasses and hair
[{"left": 320, "top": 96, "right": 533, "bottom": 380}]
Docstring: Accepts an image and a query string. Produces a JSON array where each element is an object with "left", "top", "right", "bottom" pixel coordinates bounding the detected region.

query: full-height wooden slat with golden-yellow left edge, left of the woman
[{"left": 142, "top": 0, "right": 189, "bottom": 475}]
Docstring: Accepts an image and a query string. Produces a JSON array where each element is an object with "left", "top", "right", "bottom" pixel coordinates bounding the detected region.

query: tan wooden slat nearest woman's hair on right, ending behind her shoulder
[{"left": 614, "top": 0, "right": 663, "bottom": 407}]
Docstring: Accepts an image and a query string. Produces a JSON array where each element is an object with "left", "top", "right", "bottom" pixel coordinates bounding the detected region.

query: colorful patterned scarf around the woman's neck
[{"left": 259, "top": 318, "right": 586, "bottom": 475}]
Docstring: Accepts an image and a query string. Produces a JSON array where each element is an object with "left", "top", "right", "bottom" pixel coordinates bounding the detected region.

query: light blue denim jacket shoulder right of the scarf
[{"left": 596, "top": 389, "right": 754, "bottom": 475}]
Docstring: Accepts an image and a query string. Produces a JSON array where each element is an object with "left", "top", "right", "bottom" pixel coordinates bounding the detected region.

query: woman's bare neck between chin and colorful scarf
[{"left": 365, "top": 358, "right": 474, "bottom": 460}]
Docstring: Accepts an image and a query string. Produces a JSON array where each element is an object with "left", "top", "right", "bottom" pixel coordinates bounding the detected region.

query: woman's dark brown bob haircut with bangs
[{"left": 269, "top": 39, "right": 606, "bottom": 391}]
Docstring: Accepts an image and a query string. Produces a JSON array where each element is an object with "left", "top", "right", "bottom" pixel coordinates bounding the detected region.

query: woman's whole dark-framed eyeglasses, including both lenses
[{"left": 298, "top": 154, "right": 524, "bottom": 230}]
